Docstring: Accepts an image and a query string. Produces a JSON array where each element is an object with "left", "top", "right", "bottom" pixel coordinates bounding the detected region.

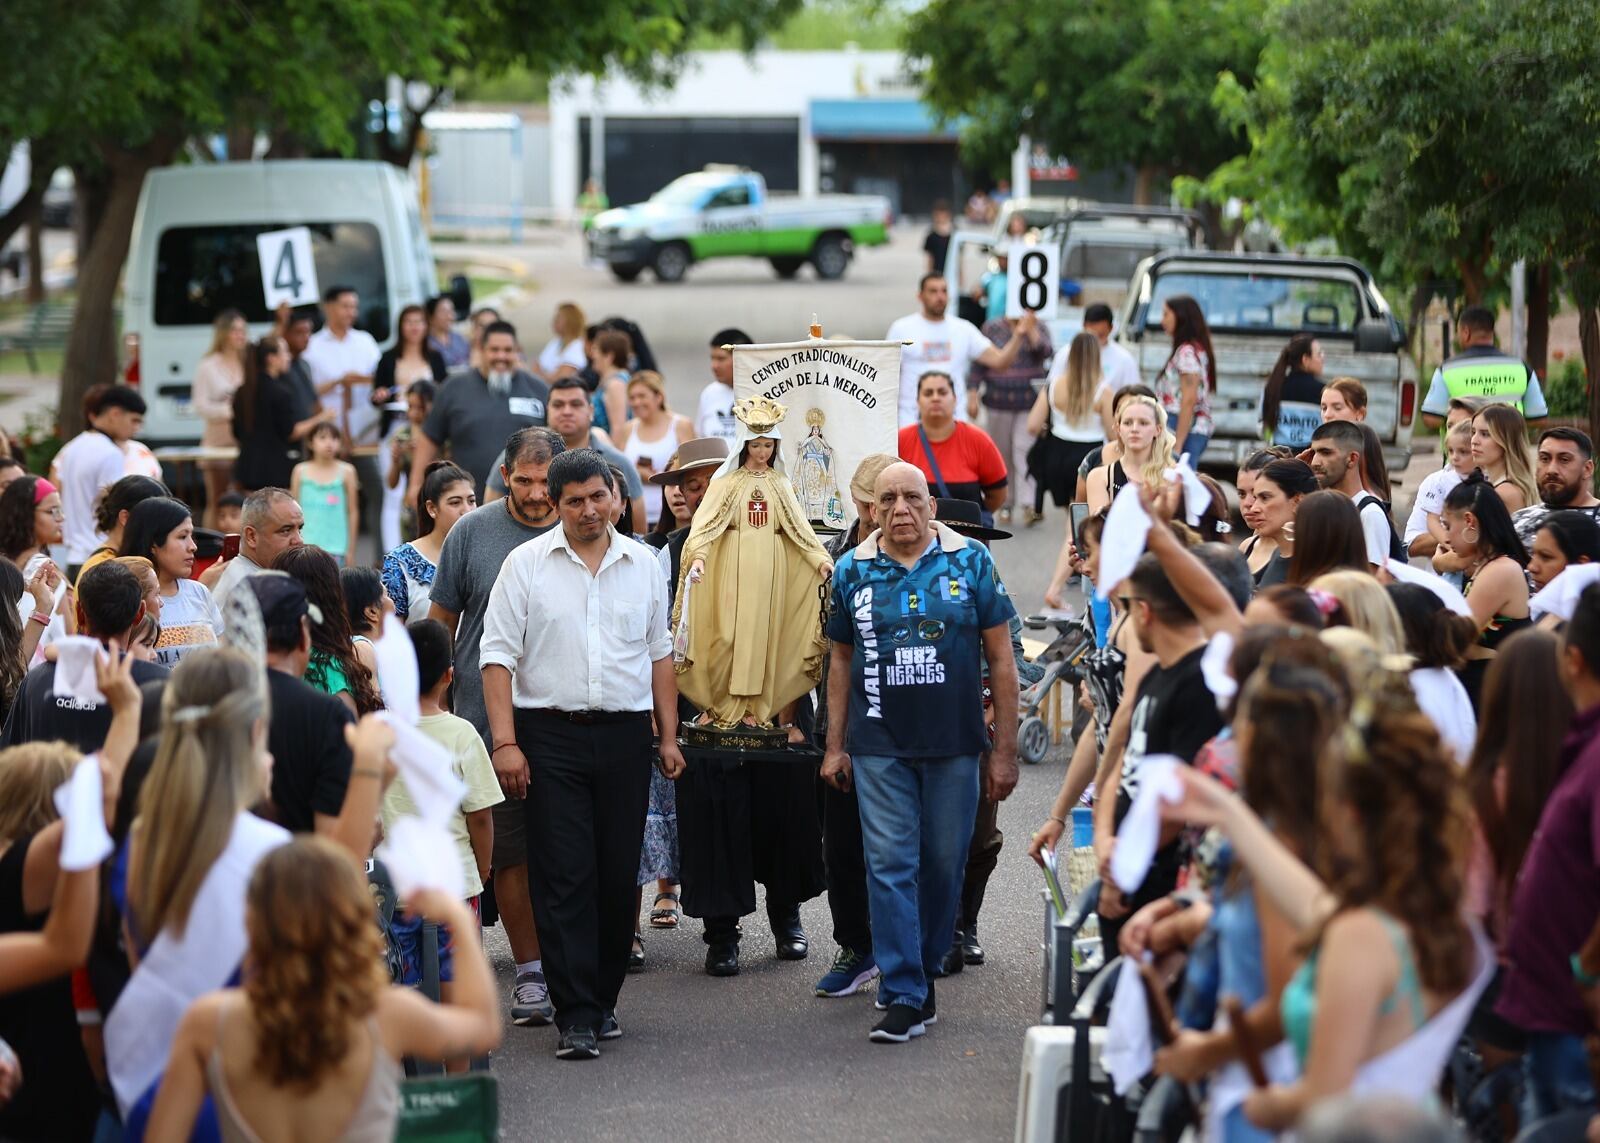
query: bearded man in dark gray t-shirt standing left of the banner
[{"left": 411, "top": 322, "right": 550, "bottom": 496}]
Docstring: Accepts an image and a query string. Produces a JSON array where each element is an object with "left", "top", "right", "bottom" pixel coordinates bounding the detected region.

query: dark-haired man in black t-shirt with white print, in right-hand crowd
[{"left": 1094, "top": 552, "right": 1222, "bottom": 956}]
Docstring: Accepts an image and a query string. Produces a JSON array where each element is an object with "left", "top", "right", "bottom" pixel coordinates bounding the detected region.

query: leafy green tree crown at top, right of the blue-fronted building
[{"left": 906, "top": 0, "right": 1269, "bottom": 202}]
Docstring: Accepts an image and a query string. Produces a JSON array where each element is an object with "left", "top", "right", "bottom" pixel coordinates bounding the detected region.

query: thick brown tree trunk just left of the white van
[{"left": 58, "top": 142, "right": 176, "bottom": 437}]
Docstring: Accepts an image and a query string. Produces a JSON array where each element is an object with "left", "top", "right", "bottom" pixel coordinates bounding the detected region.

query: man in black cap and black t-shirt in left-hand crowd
[{"left": 245, "top": 572, "right": 354, "bottom": 834}]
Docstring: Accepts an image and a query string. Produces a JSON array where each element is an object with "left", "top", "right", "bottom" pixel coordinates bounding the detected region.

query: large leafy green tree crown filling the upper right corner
[{"left": 1197, "top": 0, "right": 1600, "bottom": 432}]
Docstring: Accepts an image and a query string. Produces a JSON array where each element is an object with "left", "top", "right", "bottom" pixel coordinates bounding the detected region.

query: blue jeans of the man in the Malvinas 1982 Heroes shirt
[{"left": 853, "top": 754, "right": 978, "bottom": 1007}]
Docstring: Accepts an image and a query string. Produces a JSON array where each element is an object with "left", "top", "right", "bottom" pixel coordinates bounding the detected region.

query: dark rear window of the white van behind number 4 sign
[{"left": 154, "top": 223, "right": 390, "bottom": 341}]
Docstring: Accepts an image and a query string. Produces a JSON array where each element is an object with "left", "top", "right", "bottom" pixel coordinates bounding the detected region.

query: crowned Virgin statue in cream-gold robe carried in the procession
[{"left": 672, "top": 397, "right": 834, "bottom": 727}]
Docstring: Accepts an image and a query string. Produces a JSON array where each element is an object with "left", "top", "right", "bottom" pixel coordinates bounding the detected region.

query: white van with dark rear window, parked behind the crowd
[{"left": 123, "top": 158, "right": 472, "bottom": 445}]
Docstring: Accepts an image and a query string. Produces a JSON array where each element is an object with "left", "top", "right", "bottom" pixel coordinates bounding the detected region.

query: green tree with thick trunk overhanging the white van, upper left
[{"left": 0, "top": 0, "right": 800, "bottom": 432}]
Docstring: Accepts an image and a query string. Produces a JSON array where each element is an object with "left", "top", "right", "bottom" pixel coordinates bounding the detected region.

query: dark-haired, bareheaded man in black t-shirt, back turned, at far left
[{"left": 0, "top": 560, "right": 168, "bottom": 754}]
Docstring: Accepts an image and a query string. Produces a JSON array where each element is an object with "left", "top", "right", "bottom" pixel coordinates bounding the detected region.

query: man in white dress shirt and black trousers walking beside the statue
[{"left": 478, "top": 448, "right": 683, "bottom": 1060}]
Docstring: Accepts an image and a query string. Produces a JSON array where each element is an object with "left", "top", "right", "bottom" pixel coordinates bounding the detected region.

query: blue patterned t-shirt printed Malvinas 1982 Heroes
[{"left": 827, "top": 528, "right": 1016, "bottom": 757}]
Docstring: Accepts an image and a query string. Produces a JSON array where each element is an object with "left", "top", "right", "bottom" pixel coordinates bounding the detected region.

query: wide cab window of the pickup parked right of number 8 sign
[{"left": 1144, "top": 271, "right": 1362, "bottom": 336}]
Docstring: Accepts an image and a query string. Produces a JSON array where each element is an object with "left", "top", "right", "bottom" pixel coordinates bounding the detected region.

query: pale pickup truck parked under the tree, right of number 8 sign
[{"left": 1117, "top": 251, "right": 1418, "bottom": 472}]
